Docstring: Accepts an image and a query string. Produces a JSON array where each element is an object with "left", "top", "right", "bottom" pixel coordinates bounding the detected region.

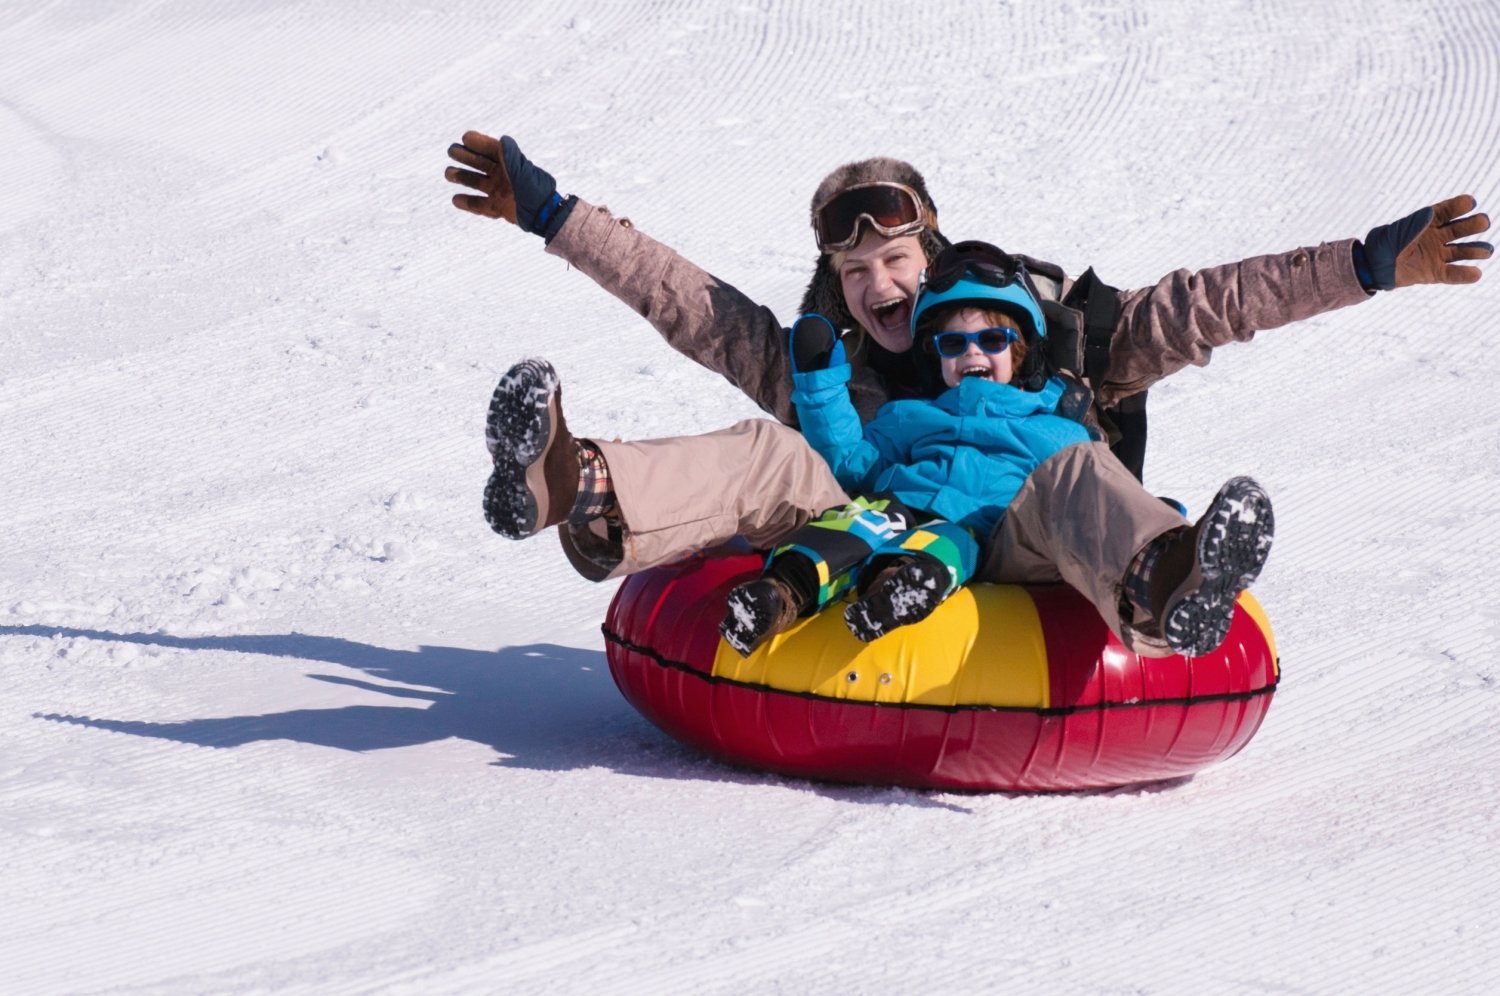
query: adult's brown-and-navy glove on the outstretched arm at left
[{"left": 443, "top": 132, "right": 578, "bottom": 242}]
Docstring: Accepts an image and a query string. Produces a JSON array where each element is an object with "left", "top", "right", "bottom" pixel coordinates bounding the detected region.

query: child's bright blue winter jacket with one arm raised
[{"left": 792, "top": 365, "right": 1091, "bottom": 537}]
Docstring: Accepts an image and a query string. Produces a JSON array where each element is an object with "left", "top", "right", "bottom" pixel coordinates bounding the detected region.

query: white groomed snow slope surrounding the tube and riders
[{"left": 0, "top": 0, "right": 1500, "bottom": 993}]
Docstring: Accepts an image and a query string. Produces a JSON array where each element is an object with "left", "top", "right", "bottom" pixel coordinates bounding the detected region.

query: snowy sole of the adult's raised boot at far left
[{"left": 485, "top": 360, "right": 558, "bottom": 540}]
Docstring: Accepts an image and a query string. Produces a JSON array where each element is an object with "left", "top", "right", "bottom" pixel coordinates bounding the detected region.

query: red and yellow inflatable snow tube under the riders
[{"left": 603, "top": 555, "right": 1280, "bottom": 792}]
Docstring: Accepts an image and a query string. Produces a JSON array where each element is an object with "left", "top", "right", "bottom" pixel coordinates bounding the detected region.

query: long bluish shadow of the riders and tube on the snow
[{"left": 11, "top": 626, "right": 963, "bottom": 809}]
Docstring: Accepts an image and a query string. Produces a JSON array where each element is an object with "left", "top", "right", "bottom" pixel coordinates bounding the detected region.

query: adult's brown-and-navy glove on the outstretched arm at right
[{"left": 1355, "top": 194, "right": 1496, "bottom": 291}]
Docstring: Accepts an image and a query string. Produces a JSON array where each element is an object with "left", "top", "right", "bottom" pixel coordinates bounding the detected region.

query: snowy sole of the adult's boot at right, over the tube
[{"left": 1163, "top": 477, "right": 1277, "bottom": 657}]
